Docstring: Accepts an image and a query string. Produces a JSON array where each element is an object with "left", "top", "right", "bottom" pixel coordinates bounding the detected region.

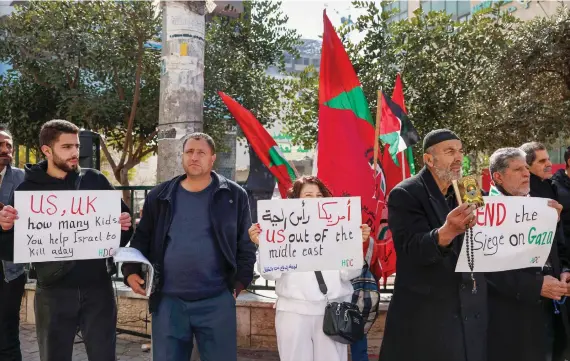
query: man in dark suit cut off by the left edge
[{"left": 0, "top": 128, "right": 26, "bottom": 361}]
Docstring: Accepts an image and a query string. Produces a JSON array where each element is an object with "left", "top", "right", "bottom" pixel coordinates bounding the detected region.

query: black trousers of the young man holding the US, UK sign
[{"left": 35, "top": 281, "right": 117, "bottom": 361}]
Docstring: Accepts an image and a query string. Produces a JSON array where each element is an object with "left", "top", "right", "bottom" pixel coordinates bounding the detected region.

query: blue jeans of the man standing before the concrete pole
[{"left": 152, "top": 291, "right": 237, "bottom": 361}]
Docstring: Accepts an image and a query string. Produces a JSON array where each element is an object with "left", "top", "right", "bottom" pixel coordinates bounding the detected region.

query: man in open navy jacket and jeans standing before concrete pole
[{"left": 123, "top": 133, "right": 255, "bottom": 361}]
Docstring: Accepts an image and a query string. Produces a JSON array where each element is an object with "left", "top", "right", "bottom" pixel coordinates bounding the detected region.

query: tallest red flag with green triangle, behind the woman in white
[{"left": 317, "top": 12, "right": 385, "bottom": 270}]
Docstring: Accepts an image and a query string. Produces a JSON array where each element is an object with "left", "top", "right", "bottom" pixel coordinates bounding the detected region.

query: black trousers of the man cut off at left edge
[{"left": 0, "top": 272, "right": 26, "bottom": 361}]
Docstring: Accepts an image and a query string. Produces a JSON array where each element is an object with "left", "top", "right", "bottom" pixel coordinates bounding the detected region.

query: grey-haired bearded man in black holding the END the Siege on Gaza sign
[{"left": 486, "top": 148, "right": 570, "bottom": 361}]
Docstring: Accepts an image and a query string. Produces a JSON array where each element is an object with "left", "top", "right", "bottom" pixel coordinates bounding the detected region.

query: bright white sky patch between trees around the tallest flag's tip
[{"left": 281, "top": 0, "right": 374, "bottom": 39}]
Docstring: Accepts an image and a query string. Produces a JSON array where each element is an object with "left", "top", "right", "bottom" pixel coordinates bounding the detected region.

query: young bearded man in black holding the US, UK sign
[{"left": 0, "top": 120, "right": 132, "bottom": 361}]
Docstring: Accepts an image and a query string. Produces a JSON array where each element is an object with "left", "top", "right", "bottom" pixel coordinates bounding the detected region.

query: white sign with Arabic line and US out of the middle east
[{"left": 257, "top": 197, "right": 363, "bottom": 273}]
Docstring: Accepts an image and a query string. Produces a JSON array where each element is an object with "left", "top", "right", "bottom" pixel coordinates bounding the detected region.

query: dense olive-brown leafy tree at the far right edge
[{"left": 466, "top": 6, "right": 570, "bottom": 146}]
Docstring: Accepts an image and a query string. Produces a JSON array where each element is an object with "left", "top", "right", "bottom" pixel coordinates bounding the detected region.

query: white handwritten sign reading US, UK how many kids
[{"left": 14, "top": 191, "right": 121, "bottom": 263}]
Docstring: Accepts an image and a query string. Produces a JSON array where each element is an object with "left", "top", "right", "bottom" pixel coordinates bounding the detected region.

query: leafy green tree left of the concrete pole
[{"left": 0, "top": 1, "right": 160, "bottom": 191}]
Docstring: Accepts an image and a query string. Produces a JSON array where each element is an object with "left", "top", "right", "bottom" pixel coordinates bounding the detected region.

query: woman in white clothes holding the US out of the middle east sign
[{"left": 249, "top": 176, "right": 370, "bottom": 361}]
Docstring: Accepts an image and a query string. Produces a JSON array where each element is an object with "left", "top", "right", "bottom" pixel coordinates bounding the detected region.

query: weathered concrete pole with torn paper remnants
[{"left": 157, "top": 1, "right": 206, "bottom": 183}]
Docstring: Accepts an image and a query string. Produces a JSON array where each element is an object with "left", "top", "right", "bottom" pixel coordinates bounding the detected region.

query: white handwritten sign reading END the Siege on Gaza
[{"left": 455, "top": 197, "right": 558, "bottom": 272}]
